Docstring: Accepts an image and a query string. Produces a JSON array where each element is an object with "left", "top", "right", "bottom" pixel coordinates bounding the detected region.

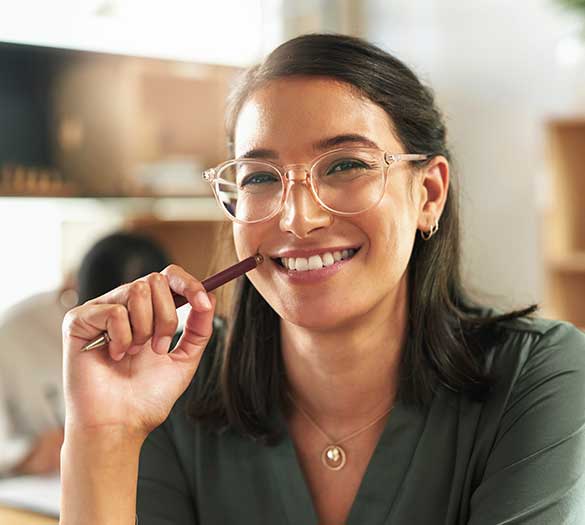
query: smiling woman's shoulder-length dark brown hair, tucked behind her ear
[{"left": 189, "top": 34, "right": 537, "bottom": 442}]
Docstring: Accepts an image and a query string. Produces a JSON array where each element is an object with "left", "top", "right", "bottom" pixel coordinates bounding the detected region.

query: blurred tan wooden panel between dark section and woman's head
[{"left": 52, "top": 55, "right": 239, "bottom": 195}]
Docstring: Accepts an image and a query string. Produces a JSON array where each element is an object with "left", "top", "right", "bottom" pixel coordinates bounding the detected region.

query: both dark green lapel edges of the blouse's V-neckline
[{"left": 270, "top": 400, "right": 427, "bottom": 525}]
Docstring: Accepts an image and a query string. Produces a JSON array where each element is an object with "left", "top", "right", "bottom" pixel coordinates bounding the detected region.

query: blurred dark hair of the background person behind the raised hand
[{"left": 77, "top": 232, "right": 170, "bottom": 304}]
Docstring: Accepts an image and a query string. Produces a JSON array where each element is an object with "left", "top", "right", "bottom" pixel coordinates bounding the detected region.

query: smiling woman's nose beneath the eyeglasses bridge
[{"left": 279, "top": 181, "right": 333, "bottom": 239}]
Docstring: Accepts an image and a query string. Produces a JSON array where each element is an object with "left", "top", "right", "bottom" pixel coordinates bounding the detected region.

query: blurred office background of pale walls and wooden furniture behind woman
[{"left": 0, "top": 0, "right": 585, "bottom": 326}]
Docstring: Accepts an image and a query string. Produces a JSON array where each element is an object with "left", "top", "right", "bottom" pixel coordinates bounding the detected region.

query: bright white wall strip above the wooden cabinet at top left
[{"left": 0, "top": 0, "right": 280, "bottom": 65}]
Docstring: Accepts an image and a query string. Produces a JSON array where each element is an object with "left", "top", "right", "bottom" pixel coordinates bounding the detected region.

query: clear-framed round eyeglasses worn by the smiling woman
[{"left": 203, "top": 148, "right": 428, "bottom": 224}]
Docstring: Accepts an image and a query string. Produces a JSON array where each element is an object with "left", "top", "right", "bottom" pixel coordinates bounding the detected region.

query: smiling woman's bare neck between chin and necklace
[{"left": 281, "top": 276, "right": 408, "bottom": 433}]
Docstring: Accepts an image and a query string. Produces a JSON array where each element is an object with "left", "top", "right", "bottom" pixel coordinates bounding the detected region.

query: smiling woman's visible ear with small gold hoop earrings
[{"left": 417, "top": 155, "right": 449, "bottom": 232}]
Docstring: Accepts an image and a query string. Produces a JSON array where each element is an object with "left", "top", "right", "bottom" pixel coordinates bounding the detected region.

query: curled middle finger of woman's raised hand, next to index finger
[{"left": 146, "top": 273, "right": 179, "bottom": 354}]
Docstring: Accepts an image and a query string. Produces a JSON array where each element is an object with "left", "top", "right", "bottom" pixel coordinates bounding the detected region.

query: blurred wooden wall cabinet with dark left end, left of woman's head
[{"left": 0, "top": 43, "right": 241, "bottom": 197}]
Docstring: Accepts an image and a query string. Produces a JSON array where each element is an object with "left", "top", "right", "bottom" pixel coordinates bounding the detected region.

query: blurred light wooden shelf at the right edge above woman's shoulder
[{"left": 544, "top": 117, "right": 585, "bottom": 328}]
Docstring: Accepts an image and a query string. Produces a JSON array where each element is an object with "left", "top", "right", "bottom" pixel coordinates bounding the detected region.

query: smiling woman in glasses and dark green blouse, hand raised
[{"left": 61, "top": 35, "right": 585, "bottom": 525}]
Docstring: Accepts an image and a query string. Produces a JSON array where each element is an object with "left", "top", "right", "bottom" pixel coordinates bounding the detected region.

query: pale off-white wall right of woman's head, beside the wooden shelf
[{"left": 365, "top": 0, "right": 585, "bottom": 306}]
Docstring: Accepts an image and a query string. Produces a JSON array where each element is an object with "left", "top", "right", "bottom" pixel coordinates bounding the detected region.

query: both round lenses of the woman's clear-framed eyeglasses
[{"left": 215, "top": 150, "right": 384, "bottom": 222}]
